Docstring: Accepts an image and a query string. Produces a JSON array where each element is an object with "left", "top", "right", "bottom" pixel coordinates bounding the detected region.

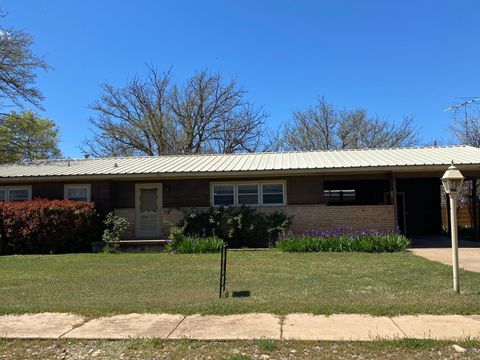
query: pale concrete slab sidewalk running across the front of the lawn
[{"left": 0, "top": 313, "right": 480, "bottom": 341}]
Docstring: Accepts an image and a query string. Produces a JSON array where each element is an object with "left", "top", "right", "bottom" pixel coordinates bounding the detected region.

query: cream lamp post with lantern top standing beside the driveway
[{"left": 442, "top": 161, "right": 464, "bottom": 293}]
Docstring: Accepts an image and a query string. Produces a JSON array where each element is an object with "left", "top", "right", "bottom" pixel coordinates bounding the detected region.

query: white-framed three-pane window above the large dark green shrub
[{"left": 211, "top": 182, "right": 285, "bottom": 206}]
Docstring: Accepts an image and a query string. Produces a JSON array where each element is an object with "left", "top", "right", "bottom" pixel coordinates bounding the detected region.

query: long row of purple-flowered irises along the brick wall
[{"left": 277, "top": 234, "right": 410, "bottom": 253}]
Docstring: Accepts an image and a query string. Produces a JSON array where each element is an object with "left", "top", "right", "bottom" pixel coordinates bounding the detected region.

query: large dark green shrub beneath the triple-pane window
[{"left": 181, "top": 206, "right": 293, "bottom": 248}]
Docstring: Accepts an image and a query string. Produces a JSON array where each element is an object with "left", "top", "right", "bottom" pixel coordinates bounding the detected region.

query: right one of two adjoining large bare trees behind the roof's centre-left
[{"left": 170, "top": 70, "right": 267, "bottom": 154}]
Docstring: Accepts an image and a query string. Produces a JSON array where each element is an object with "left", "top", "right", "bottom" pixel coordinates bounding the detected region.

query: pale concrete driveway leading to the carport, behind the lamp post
[{"left": 410, "top": 247, "right": 480, "bottom": 272}]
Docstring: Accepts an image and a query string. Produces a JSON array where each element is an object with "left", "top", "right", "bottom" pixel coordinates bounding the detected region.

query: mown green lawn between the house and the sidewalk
[{"left": 0, "top": 250, "right": 480, "bottom": 316}]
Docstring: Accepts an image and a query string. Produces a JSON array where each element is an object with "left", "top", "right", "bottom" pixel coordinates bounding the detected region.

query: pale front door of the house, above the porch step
[{"left": 135, "top": 184, "right": 162, "bottom": 238}]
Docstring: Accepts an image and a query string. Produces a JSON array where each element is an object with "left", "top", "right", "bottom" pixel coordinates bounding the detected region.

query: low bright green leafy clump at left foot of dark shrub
[{"left": 167, "top": 227, "right": 225, "bottom": 254}]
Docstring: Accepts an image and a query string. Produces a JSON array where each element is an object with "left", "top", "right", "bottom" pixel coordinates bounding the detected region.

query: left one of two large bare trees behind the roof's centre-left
[{"left": 81, "top": 67, "right": 180, "bottom": 156}]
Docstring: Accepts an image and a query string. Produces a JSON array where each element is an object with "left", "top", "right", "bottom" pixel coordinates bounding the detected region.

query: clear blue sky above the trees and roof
[{"left": 0, "top": 0, "right": 480, "bottom": 157}]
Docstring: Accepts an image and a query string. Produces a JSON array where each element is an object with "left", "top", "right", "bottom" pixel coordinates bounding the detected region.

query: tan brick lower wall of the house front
[{"left": 115, "top": 205, "right": 395, "bottom": 238}]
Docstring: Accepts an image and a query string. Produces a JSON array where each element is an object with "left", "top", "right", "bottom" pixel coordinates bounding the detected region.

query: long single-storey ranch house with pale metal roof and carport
[{"left": 0, "top": 146, "right": 480, "bottom": 239}]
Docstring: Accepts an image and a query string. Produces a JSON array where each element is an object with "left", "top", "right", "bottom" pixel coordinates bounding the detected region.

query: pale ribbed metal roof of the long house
[{"left": 0, "top": 146, "right": 480, "bottom": 181}]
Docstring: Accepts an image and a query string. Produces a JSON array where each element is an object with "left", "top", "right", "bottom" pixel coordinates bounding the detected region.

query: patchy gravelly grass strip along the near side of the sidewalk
[{"left": 0, "top": 339, "right": 480, "bottom": 360}]
